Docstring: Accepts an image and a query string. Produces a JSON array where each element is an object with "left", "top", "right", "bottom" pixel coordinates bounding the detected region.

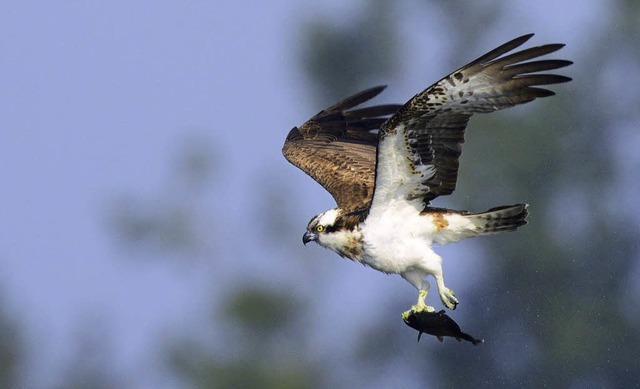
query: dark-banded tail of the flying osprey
[{"left": 465, "top": 204, "right": 529, "bottom": 235}]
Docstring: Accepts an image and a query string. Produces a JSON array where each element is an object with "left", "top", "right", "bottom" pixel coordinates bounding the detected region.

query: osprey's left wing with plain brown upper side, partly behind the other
[{"left": 282, "top": 86, "right": 401, "bottom": 212}]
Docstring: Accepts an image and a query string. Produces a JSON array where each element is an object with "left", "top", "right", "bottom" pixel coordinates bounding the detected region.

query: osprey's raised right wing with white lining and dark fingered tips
[{"left": 372, "top": 34, "right": 572, "bottom": 211}]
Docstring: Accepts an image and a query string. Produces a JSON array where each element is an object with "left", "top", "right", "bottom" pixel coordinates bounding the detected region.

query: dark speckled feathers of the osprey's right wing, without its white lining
[{"left": 381, "top": 34, "right": 571, "bottom": 205}]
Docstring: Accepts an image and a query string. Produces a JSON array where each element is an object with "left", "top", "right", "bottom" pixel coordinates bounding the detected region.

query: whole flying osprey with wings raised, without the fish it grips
[{"left": 282, "top": 34, "right": 572, "bottom": 312}]
